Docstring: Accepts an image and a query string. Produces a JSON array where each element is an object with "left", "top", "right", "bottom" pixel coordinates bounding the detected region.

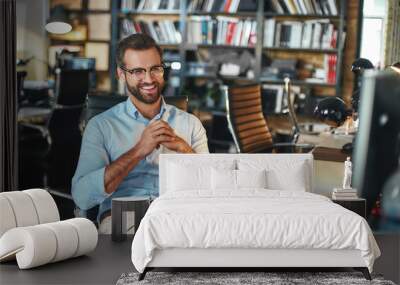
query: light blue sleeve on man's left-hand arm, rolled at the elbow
[{"left": 71, "top": 119, "right": 110, "bottom": 210}]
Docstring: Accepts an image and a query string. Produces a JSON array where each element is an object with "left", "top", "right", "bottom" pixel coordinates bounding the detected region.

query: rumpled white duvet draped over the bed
[{"left": 132, "top": 189, "right": 380, "bottom": 272}]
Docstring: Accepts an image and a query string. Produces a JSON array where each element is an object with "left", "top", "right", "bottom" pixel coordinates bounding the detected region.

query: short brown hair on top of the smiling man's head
[{"left": 117, "top": 34, "right": 162, "bottom": 66}]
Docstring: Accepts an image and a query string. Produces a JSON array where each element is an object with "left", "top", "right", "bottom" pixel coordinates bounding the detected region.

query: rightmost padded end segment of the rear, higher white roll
[{"left": 23, "top": 189, "right": 60, "bottom": 224}]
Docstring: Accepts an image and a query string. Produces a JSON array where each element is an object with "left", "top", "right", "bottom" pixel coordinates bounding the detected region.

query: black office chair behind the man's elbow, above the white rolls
[{"left": 19, "top": 70, "right": 89, "bottom": 218}]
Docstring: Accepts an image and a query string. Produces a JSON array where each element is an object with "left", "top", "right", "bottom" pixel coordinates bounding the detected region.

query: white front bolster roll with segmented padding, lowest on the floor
[{"left": 0, "top": 218, "right": 98, "bottom": 269}]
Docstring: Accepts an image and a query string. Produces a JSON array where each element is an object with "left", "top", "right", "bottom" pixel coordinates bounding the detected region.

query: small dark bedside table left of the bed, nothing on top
[{"left": 111, "top": 196, "right": 150, "bottom": 241}]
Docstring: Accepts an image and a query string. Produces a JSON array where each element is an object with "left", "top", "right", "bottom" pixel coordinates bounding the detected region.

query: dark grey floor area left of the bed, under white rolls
[{"left": 0, "top": 235, "right": 135, "bottom": 285}]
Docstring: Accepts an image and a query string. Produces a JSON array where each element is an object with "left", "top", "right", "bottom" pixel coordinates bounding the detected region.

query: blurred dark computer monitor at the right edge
[{"left": 353, "top": 71, "right": 400, "bottom": 218}]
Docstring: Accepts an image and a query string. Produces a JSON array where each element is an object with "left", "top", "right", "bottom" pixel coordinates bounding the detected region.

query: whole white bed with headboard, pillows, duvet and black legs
[{"left": 132, "top": 154, "right": 380, "bottom": 278}]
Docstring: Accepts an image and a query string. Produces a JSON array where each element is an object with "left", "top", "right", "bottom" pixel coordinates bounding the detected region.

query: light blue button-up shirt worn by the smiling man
[{"left": 72, "top": 98, "right": 208, "bottom": 217}]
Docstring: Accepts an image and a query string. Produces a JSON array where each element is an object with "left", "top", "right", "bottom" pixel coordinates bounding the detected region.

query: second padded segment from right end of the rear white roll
[{"left": 1, "top": 191, "right": 39, "bottom": 227}]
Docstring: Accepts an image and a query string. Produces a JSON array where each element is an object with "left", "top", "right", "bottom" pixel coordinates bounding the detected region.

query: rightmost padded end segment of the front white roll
[{"left": 65, "top": 218, "right": 98, "bottom": 257}]
